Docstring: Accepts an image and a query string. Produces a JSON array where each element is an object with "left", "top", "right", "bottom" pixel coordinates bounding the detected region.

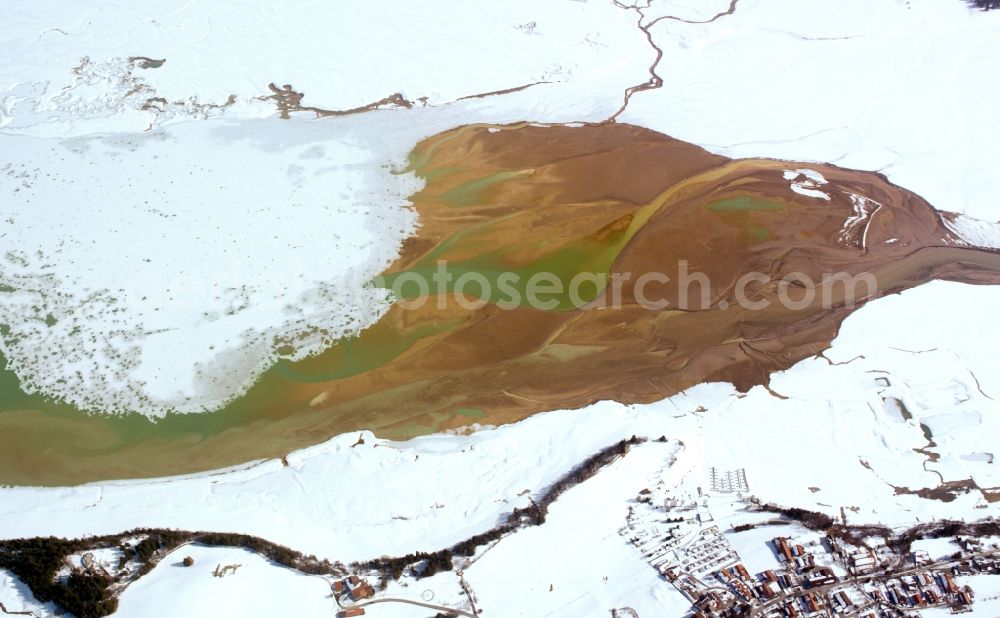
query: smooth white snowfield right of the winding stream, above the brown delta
[{"left": 619, "top": 0, "right": 1000, "bottom": 221}]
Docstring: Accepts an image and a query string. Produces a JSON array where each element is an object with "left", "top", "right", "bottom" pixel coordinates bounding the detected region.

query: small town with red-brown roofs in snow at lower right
[{"left": 620, "top": 460, "right": 1000, "bottom": 618}]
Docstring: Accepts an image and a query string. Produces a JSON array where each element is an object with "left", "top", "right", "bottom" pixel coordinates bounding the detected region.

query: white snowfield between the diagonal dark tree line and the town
[{"left": 465, "top": 443, "right": 688, "bottom": 616}]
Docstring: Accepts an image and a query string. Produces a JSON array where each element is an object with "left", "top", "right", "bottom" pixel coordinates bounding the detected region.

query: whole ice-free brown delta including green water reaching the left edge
[{"left": 0, "top": 123, "right": 1000, "bottom": 484}]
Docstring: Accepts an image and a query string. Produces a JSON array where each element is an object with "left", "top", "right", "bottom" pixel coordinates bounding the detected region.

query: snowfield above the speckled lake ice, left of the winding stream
[{"left": 0, "top": 0, "right": 649, "bottom": 135}]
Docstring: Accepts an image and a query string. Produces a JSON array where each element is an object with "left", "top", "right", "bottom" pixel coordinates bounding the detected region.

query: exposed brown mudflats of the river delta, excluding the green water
[{"left": 334, "top": 124, "right": 1000, "bottom": 426}]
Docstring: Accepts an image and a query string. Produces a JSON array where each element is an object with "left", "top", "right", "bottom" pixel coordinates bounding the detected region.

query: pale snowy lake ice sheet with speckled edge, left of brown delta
[{"left": 0, "top": 119, "right": 420, "bottom": 414}]
